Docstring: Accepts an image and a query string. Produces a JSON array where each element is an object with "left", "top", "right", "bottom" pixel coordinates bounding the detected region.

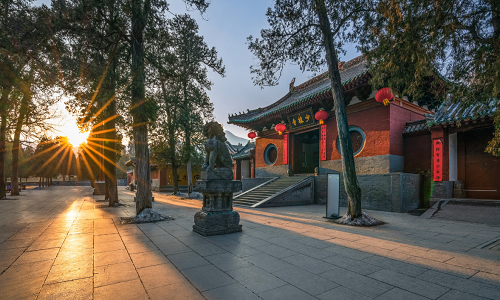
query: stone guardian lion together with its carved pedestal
[{"left": 193, "top": 122, "right": 242, "bottom": 236}]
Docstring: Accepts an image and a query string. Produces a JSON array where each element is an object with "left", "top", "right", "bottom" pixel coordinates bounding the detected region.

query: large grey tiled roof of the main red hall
[{"left": 229, "top": 56, "right": 367, "bottom": 123}]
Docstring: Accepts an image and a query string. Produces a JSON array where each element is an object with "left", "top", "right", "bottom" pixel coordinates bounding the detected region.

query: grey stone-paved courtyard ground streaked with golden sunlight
[{"left": 0, "top": 187, "right": 500, "bottom": 300}]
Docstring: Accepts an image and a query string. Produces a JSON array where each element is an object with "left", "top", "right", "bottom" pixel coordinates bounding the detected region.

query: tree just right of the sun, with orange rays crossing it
[{"left": 54, "top": 0, "right": 130, "bottom": 206}]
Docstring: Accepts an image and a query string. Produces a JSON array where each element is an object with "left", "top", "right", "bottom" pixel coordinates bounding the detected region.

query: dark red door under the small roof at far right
[{"left": 464, "top": 127, "right": 500, "bottom": 199}]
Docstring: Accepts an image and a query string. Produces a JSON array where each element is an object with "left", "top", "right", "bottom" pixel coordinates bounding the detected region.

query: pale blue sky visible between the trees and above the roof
[{"left": 35, "top": 0, "right": 360, "bottom": 138}]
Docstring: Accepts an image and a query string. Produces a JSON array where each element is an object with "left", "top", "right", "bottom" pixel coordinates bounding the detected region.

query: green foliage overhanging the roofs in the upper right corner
[{"left": 362, "top": 0, "right": 500, "bottom": 156}]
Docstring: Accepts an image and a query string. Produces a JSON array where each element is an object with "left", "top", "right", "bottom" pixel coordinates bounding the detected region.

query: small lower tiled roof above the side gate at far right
[{"left": 426, "top": 98, "right": 500, "bottom": 127}]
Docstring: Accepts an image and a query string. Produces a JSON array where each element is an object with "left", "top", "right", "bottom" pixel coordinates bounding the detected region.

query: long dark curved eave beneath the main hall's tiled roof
[{"left": 228, "top": 70, "right": 368, "bottom": 125}]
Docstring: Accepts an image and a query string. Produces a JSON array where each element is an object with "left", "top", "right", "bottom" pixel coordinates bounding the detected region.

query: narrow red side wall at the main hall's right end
[{"left": 389, "top": 102, "right": 425, "bottom": 156}]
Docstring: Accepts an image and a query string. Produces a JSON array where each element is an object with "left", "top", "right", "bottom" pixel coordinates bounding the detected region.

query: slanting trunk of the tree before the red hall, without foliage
[{"left": 315, "top": 0, "right": 362, "bottom": 219}]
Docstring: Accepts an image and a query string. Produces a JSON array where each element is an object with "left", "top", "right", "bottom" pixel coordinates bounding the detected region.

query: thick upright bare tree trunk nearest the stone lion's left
[{"left": 131, "top": 0, "right": 153, "bottom": 214}]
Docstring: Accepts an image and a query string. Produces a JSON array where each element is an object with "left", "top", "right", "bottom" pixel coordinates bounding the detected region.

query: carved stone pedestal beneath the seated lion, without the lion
[{"left": 193, "top": 180, "right": 241, "bottom": 236}]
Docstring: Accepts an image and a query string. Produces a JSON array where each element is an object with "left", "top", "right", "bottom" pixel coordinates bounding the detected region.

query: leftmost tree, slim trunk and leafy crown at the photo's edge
[{"left": 0, "top": 0, "right": 60, "bottom": 195}]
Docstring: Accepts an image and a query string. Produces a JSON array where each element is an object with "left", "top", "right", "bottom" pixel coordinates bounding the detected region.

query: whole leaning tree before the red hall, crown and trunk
[{"left": 248, "top": 0, "right": 378, "bottom": 223}]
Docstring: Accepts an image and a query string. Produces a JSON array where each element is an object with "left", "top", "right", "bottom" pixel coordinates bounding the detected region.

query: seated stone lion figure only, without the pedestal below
[{"left": 201, "top": 122, "right": 233, "bottom": 180}]
